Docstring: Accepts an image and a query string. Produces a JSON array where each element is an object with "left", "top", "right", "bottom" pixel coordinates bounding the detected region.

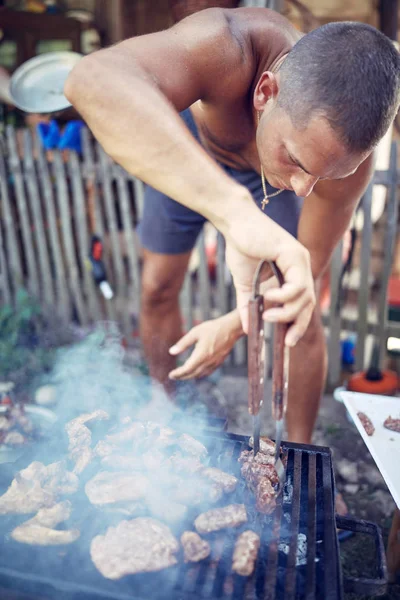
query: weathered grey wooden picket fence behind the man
[{"left": 0, "top": 127, "right": 398, "bottom": 383}]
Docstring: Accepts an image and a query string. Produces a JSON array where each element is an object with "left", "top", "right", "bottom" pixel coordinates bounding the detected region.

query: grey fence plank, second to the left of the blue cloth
[{"left": 23, "top": 129, "right": 55, "bottom": 309}]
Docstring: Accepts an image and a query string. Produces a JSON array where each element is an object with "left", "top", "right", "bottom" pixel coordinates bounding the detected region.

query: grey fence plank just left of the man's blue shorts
[{"left": 116, "top": 167, "right": 140, "bottom": 315}]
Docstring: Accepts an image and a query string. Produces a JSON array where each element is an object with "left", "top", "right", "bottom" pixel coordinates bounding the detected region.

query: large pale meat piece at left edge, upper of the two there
[{"left": 0, "top": 461, "right": 79, "bottom": 514}]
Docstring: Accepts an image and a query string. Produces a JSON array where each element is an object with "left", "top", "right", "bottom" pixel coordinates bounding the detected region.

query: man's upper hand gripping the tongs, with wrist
[{"left": 225, "top": 198, "right": 315, "bottom": 346}]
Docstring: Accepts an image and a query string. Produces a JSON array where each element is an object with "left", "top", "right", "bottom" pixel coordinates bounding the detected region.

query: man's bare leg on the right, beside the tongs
[{"left": 286, "top": 300, "right": 327, "bottom": 444}]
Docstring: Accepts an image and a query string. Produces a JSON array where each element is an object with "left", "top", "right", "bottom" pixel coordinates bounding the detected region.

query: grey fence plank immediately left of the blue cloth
[{"left": 34, "top": 136, "right": 72, "bottom": 323}]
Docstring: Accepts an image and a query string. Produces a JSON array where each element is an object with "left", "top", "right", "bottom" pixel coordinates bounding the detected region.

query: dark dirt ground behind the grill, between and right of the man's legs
[{"left": 203, "top": 374, "right": 400, "bottom": 600}]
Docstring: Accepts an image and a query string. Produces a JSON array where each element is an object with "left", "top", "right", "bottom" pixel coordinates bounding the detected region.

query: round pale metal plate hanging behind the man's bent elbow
[{"left": 10, "top": 52, "right": 82, "bottom": 113}]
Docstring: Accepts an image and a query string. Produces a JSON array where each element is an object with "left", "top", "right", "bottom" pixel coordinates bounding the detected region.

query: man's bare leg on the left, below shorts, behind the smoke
[{"left": 140, "top": 249, "right": 191, "bottom": 393}]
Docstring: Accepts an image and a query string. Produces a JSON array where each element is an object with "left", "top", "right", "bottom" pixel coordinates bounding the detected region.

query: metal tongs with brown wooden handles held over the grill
[{"left": 248, "top": 260, "right": 289, "bottom": 483}]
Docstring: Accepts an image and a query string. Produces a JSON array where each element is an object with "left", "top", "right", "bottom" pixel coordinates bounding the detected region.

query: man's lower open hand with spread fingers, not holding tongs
[{"left": 169, "top": 311, "right": 243, "bottom": 380}]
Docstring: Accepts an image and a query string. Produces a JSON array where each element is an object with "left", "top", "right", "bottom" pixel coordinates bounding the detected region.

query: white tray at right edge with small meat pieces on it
[{"left": 340, "top": 391, "right": 400, "bottom": 508}]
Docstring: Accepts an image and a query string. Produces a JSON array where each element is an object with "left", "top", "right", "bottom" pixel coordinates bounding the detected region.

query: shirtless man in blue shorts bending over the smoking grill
[{"left": 65, "top": 8, "right": 400, "bottom": 443}]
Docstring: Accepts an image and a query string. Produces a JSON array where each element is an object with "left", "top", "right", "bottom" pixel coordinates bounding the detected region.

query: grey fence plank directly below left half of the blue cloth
[{"left": 53, "top": 151, "right": 88, "bottom": 326}]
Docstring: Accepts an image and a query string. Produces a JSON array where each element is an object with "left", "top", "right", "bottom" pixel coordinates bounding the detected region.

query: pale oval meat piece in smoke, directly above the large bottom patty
[{"left": 85, "top": 471, "right": 149, "bottom": 506}]
